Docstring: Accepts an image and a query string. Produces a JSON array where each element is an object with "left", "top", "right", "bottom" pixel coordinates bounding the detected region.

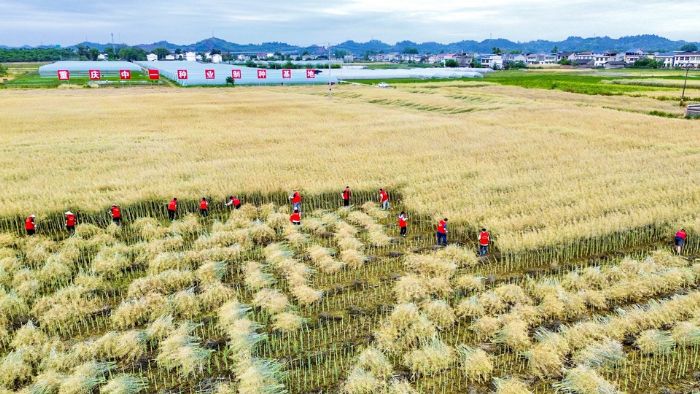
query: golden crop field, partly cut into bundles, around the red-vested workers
[{"left": 0, "top": 81, "right": 700, "bottom": 394}]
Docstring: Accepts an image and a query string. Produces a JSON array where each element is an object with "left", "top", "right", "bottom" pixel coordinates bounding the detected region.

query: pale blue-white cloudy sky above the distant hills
[{"left": 0, "top": 0, "right": 700, "bottom": 45}]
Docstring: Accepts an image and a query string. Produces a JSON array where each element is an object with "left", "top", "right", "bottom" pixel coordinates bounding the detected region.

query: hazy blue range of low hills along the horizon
[{"left": 6, "top": 34, "right": 700, "bottom": 55}]
